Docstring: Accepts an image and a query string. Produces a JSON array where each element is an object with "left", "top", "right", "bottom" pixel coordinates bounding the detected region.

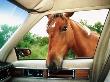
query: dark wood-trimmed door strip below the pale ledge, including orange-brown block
[{"left": 12, "top": 68, "right": 90, "bottom": 80}]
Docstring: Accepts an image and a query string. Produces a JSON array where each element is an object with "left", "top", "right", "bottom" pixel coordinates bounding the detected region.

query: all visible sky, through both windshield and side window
[{"left": 0, "top": 0, "right": 108, "bottom": 36}]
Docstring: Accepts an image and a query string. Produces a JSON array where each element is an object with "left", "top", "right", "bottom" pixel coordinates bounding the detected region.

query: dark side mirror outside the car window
[{"left": 15, "top": 48, "right": 31, "bottom": 58}]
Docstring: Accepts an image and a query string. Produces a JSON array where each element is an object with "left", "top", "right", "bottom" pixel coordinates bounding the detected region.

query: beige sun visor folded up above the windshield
[{"left": 8, "top": 0, "right": 54, "bottom": 12}]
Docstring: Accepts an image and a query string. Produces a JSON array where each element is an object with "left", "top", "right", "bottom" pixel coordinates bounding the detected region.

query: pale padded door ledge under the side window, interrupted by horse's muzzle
[{"left": 13, "top": 59, "right": 93, "bottom": 70}]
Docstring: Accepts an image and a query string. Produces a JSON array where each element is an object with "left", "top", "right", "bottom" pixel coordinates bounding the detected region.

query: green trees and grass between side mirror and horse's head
[{"left": 17, "top": 32, "right": 48, "bottom": 59}]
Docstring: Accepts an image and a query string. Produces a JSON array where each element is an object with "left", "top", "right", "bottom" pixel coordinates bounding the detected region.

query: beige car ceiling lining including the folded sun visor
[{"left": 9, "top": 0, "right": 110, "bottom": 13}]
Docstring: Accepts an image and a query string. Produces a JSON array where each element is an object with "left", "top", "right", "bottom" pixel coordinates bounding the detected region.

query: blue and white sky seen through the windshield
[{"left": 0, "top": 0, "right": 28, "bottom": 26}]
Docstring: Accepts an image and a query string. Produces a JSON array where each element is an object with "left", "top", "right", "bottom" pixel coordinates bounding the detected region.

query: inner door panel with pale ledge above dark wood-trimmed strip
[{"left": 13, "top": 59, "right": 93, "bottom": 79}]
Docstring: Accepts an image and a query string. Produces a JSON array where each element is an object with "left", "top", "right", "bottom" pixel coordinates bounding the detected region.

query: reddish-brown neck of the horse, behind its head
[{"left": 70, "top": 20, "right": 92, "bottom": 57}]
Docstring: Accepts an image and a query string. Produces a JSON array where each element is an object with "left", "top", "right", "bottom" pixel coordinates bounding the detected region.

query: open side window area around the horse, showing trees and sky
[{"left": 16, "top": 9, "right": 109, "bottom": 59}]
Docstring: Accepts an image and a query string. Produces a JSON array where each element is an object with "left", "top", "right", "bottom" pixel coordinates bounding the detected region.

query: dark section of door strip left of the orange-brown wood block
[{"left": 13, "top": 68, "right": 74, "bottom": 79}]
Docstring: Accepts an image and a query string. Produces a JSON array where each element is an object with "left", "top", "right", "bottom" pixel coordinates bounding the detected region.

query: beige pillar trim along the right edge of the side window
[{"left": 92, "top": 11, "right": 110, "bottom": 82}]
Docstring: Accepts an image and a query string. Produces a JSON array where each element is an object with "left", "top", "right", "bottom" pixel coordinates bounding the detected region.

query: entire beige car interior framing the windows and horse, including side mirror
[{"left": 0, "top": 0, "right": 110, "bottom": 82}]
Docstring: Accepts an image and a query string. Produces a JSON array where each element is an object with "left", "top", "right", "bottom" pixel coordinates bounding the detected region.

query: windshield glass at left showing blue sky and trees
[{"left": 0, "top": 0, "right": 28, "bottom": 48}]
